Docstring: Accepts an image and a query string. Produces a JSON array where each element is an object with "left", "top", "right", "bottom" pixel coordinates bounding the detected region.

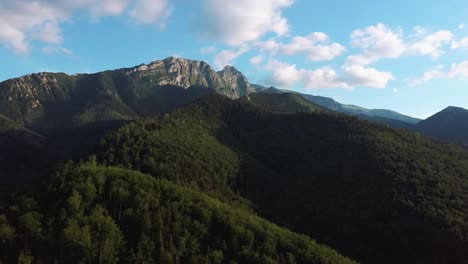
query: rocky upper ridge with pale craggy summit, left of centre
[{"left": 0, "top": 57, "right": 255, "bottom": 129}]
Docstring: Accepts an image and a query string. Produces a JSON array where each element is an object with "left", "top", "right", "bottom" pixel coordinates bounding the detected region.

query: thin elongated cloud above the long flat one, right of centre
[{"left": 256, "top": 32, "right": 346, "bottom": 61}]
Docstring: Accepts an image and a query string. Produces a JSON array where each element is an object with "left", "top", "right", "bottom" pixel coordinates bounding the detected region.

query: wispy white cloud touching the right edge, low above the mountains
[{"left": 407, "top": 61, "right": 468, "bottom": 86}]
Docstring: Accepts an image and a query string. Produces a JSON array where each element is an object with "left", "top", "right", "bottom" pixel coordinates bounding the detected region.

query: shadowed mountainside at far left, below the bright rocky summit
[{"left": 0, "top": 70, "right": 212, "bottom": 188}]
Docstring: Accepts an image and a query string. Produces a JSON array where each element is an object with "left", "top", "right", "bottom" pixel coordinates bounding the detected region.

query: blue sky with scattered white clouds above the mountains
[{"left": 0, "top": 0, "right": 468, "bottom": 118}]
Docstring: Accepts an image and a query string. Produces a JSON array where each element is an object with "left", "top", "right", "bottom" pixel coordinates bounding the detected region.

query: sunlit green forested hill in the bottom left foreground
[{"left": 0, "top": 162, "right": 353, "bottom": 263}]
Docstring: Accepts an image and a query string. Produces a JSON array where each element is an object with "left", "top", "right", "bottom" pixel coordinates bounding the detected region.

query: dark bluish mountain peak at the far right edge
[{"left": 415, "top": 106, "right": 468, "bottom": 146}]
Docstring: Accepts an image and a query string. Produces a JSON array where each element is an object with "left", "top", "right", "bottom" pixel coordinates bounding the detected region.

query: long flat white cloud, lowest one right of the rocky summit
[{"left": 266, "top": 61, "right": 394, "bottom": 89}]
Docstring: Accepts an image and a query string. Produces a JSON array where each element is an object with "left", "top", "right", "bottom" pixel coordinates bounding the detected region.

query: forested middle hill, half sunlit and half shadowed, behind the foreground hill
[{"left": 97, "top": 95, "right": 468, "bottom": 263}]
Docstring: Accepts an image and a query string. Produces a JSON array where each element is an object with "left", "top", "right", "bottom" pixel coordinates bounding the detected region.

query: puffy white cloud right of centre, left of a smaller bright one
[{"left": 347, "top": 23, "right": 405, "bottom": 65}]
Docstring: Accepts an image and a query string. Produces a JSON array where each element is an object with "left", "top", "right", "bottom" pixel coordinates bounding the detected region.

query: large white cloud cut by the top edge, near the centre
[{"left": 196, "top": 0, "right": 294, "bottom": 45}]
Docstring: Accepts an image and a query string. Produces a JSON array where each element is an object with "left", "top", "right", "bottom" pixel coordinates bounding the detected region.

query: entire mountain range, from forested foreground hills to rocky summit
[{"left": 0, "top": 58, "right": 468, "bottom": 264}]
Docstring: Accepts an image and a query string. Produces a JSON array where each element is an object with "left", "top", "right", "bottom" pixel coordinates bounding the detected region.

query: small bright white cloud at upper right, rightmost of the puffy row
[{"left": 407, "top": 30, "right": 453, "bottom": 59}]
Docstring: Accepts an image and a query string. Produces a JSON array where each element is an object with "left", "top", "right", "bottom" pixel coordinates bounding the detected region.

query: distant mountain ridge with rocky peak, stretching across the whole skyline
[{"left": 0, "top": 57, "right": 468, "bottom": 148}]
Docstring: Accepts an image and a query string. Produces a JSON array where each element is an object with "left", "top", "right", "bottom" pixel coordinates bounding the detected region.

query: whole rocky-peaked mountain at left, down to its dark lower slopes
[{"left": 0, "top": 57, "right": 254, "bottom": 188}]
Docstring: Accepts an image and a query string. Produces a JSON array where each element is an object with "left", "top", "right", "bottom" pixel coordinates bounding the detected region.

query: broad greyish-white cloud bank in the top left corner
[{"left": 0, "top": 0, "right": 171, "bottom": 54}]
